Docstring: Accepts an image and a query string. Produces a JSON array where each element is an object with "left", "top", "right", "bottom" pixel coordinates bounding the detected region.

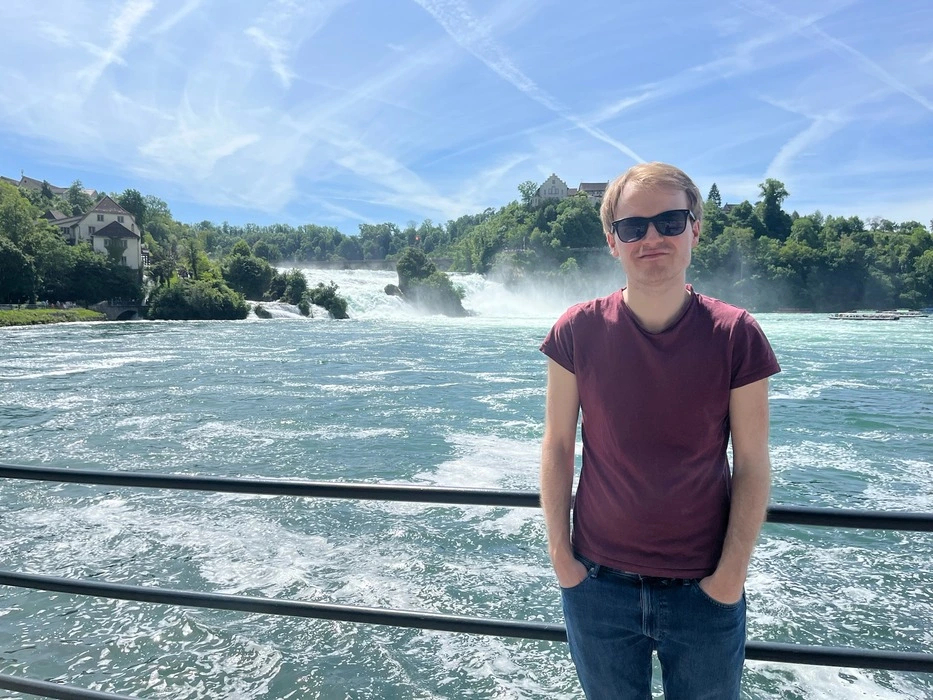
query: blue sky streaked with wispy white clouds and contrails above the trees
[{"left": 0, "top": 0, "right": 933, "bottom": 233}]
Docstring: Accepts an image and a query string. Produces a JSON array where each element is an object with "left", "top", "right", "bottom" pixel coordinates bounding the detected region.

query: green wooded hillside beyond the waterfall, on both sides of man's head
[{"left": 135, "top": 179, "right": 933, "bottom": 311}]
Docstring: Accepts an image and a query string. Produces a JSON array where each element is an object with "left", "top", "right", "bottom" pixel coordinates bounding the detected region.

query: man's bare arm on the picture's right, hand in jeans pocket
[{"left": 700, "top": 379, "right": 771, "bottom": 603}]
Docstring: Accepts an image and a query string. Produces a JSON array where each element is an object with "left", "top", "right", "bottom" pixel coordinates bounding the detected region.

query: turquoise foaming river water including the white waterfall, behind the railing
[{"left": 0, "top": 270, "right": 933, "bottom": 699}]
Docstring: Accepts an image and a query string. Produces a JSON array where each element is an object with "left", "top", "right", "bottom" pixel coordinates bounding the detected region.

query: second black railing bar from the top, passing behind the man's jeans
[{"left": 0, "top": 570, "right": 933, "bottom": 673}]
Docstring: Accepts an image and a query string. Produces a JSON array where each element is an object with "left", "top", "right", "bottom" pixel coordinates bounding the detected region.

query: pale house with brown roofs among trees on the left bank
[{"left": 48, "top": 196, "right": 148, "bottom": 270}]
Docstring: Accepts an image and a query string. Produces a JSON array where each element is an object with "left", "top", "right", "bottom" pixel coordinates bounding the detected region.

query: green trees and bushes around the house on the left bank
[{"left": 0, "top": 181, "right": 347, "bottom": 319}]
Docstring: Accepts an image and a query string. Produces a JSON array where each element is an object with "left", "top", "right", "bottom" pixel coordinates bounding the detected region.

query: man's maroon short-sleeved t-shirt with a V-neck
[{"left": 541, "top": 285, "right": 781, "bottom": 578}]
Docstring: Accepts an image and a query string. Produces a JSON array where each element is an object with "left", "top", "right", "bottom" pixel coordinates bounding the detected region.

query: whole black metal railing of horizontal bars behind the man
[{"left": 0, "top": 464, "right": 933, "bottom": 700}]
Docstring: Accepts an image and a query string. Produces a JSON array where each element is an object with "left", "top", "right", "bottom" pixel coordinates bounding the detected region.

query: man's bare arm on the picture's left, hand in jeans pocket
[{"left": 541, "top": 359, "right": 586, "bottom": 588}]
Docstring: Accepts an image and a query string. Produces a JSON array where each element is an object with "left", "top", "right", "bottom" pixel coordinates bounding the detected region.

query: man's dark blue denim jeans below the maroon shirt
[{"left": 561, "top": 555, "right": 745, "bottom": 700}]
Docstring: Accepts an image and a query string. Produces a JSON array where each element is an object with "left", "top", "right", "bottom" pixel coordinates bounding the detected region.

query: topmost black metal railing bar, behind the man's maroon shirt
[{"left": 0, "top": 464, "right": 933, "bottom": 532}]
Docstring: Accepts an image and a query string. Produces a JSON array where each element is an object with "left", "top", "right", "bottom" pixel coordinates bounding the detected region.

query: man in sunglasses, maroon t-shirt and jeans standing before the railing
[{"left": 541, "top": 163, "right": 780, "bottom": 700}]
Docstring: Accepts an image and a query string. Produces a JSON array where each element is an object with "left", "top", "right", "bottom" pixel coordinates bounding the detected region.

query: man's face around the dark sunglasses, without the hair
[{"left": 606, "top": 185, "right": 700, "bottom": 288}]
